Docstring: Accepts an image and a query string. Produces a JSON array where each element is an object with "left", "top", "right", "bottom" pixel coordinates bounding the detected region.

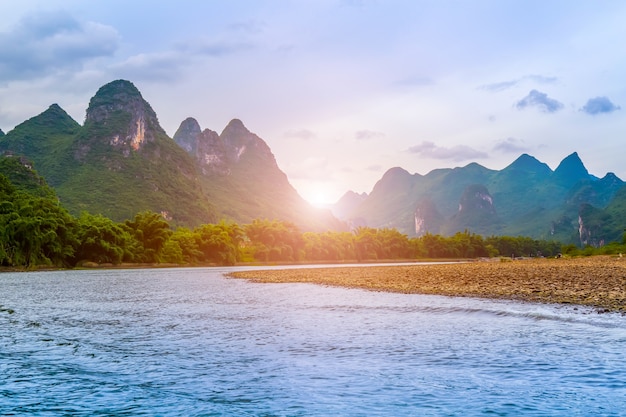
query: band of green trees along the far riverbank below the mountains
[{"left": 0, "top": 169, "right": 625, "bottom": 269}]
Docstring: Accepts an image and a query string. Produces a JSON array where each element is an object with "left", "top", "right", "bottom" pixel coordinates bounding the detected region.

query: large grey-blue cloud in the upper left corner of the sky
[{"left": 0, "top": 12, "right": 120, "bottom": 81}]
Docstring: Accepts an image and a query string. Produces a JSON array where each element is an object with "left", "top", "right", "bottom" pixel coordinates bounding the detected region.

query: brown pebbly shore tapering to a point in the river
[{"left": 230, "top": 256, "right": 626, "bottom": 312}]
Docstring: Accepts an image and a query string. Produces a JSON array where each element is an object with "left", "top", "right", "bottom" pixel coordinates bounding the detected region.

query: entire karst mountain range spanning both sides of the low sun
[{"left": 0, "top": 80, "right": 626, "bottom": 246}]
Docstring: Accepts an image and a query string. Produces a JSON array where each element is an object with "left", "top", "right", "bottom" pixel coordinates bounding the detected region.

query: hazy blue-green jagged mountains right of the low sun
[{"left": 336, "top": 153, "right": 624, "bottom": 244}]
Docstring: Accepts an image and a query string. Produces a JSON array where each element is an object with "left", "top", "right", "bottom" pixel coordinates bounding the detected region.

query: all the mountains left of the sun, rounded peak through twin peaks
[{"left": 0, "top": 80, "right": 344, "bottom": 230}]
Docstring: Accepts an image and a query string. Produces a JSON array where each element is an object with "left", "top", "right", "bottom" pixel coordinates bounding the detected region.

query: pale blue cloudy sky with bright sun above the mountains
[{"left": 0, "top": 0, "right": 626, "bottom": 204}]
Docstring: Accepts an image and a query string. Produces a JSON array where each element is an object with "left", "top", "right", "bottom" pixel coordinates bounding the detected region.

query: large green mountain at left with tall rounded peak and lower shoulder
[{"left": 0, "top": 80, "right": 216, "bottom": 224}]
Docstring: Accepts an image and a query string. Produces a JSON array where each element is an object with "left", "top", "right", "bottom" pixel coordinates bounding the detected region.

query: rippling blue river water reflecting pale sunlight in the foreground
[{"left": 0, "top": 268, "right": 626, "bottom": 416}]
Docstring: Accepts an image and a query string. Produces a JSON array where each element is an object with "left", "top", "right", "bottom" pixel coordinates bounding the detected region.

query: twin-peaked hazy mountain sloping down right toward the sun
[{"left": 174, "top": 118, "right": 345, "bottom": 231}]
